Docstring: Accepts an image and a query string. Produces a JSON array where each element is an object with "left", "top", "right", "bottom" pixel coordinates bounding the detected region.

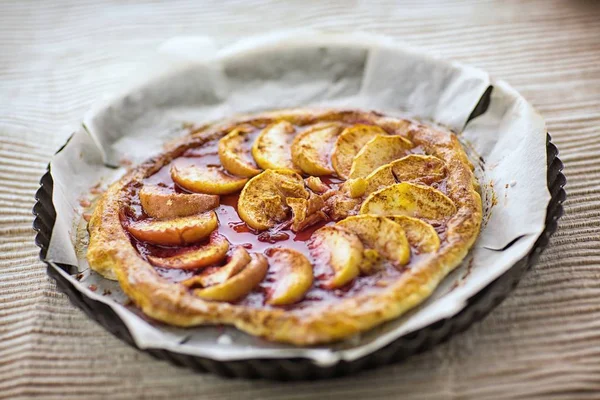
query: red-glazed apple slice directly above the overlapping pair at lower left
[{"left": 148, "top": 232, "right": 229, "bottom": 269}]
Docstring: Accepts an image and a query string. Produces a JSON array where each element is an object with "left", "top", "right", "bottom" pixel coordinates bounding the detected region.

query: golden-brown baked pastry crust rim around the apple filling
[{"left": 87, "top": 109, "right": 482, "bottom": 345}]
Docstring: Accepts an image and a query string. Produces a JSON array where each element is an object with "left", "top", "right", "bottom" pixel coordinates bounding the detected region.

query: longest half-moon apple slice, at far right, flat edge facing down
[{"left": 360, "top": 182, "right": 456, "bottom": 221}]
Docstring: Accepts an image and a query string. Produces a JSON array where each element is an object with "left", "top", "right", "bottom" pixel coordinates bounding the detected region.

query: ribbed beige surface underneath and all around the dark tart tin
[{"left": 0, "top": 0, "right": 600, "bottom": 399}]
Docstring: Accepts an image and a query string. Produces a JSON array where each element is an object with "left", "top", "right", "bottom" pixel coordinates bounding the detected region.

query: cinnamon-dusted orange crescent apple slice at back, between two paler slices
[{"left": 331, "top": 124, "right": 387, "bottom": 179}]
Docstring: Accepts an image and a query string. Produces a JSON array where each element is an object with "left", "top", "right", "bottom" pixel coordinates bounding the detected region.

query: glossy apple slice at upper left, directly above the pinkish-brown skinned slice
[{"left": 171, "top": 164, "right": 248, "bottom": 194}]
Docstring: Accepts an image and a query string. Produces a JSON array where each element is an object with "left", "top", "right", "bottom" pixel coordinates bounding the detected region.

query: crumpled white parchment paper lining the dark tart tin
[{"left": 47, "top": 31, "right": 550, "bottom": 365}]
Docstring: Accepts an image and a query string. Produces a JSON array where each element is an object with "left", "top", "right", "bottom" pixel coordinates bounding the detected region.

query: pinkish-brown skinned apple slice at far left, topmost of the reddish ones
[{"left": 140, "top": 185, "right": 219, "bottom": 219}]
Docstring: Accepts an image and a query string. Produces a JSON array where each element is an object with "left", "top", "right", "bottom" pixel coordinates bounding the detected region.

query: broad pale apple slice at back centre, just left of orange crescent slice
[{"left": 292, "top": 123, "right": 342, "bottom": 176}]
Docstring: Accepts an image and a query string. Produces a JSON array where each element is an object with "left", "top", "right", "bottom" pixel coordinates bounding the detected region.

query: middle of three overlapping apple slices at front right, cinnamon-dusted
[{"left": 336, "top": 215, "right": 410, "bottom": 265}]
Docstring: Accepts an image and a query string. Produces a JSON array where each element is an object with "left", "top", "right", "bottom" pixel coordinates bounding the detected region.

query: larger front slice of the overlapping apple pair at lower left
[{"left": 194, "top": 254, "right": 269, "bottom": 301}]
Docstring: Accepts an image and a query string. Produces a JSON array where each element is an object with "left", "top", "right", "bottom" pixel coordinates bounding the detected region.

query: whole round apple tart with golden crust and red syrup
[{"left": 87, "top": 109, "right": 482, "bottom": 345}]
